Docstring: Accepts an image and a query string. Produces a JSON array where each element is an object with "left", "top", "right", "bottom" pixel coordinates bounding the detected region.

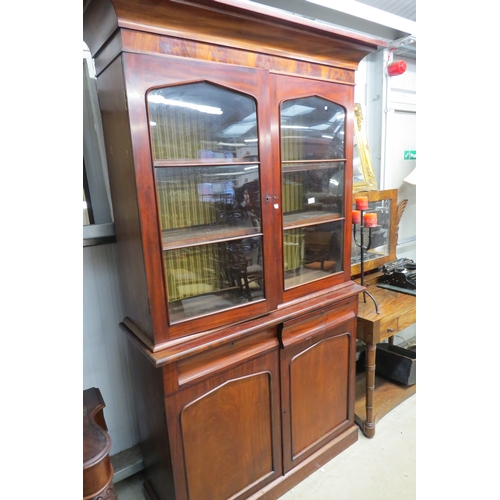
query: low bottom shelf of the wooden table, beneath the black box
[{"left": 354, "top": 372, "right": 417, "bottom": 428}]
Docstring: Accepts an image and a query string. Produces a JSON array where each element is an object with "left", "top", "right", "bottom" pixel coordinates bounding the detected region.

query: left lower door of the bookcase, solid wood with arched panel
[{"left": 166, "top": 349, "right": 282, "bottom": 500}]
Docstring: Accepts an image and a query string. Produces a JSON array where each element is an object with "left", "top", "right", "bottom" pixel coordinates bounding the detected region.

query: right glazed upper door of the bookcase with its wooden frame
[{"left": 271, "top": 75, "right": 353, "bottom": 302}]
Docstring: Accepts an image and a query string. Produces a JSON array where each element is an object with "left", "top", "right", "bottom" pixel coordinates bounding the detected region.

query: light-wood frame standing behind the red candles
[{"left": 351, "top": 189, "right": 400, "bottom": 277}]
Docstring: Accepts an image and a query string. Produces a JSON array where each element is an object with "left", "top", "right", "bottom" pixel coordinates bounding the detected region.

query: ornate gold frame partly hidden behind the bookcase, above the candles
[{"left": 352, "top": 103, "right": 378, "bottom": 193}]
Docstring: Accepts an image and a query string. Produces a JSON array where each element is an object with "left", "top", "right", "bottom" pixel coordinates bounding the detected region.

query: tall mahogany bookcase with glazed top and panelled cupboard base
[{"left": 84, "top": 0, "right": 378, "bottom": 500}]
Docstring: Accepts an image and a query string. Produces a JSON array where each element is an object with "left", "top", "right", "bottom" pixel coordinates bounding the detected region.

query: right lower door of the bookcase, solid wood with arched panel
[{"left": 280, "top": 300, "right": 356, "bottom": 473}]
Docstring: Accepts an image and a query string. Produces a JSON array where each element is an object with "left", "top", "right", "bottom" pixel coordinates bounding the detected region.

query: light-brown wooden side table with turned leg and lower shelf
[{"left": 354, "top": 284, "right": 417, "bottom": 437}]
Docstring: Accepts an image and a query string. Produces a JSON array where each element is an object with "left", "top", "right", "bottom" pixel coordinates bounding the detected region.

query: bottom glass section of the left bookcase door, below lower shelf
[{"left": 164, "top": 236, "right": 264, "bottom": 323}]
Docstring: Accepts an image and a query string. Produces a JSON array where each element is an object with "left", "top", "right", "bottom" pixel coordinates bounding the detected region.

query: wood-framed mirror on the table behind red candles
[{"left": 351, "top": 189, "right": 404, "bottom": 277}]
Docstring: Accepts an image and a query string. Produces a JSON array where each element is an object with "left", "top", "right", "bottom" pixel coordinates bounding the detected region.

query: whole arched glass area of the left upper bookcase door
[{"left": 147, "top": 81, "right": 265, "bottom": 324}]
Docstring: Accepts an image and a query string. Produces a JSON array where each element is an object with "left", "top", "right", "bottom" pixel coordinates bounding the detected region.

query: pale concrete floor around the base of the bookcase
[{"left": 115, "top": 394, "right": 417, "bottom": 500}]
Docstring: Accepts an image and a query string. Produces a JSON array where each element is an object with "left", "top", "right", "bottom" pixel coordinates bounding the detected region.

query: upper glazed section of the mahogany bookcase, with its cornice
[{"left": 84, "top": 0, "right": 375, "bottom": 350}]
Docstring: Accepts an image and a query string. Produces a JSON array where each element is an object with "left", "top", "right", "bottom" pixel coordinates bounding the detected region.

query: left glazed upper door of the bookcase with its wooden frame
[{"left": 123, "top": 53, "right": 277, "bottom": 341}]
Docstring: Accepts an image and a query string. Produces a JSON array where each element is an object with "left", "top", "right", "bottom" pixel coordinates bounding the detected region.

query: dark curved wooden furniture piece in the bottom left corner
[{"left": 83, "top": 387, "right": 118, "bottom": 500}]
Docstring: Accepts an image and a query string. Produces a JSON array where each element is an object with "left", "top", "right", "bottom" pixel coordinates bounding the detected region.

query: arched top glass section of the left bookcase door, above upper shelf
[{"left": 148, "top": 82, "right": 258, "bottom": 161}]
